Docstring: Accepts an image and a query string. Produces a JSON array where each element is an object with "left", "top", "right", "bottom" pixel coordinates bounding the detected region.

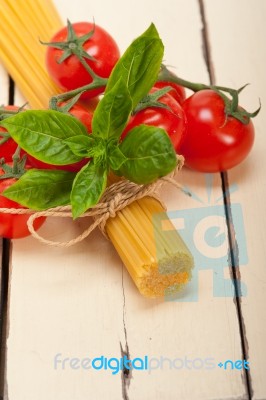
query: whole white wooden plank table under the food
[{"left": 0, "top": 0, "right": 266, "bottom": 400}]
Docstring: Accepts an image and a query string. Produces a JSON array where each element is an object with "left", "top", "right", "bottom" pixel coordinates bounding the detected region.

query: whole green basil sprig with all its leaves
[{"left": 1, "top": 24, "right": 176, "bottom": 218}]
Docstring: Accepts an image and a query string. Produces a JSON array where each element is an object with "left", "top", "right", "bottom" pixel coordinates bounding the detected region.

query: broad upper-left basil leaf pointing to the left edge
[{"left": 1, "top": 110, "right": 88, "bottom": 165}]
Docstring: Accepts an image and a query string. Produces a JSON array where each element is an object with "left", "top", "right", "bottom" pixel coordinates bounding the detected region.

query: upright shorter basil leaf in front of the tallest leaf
[{"left": 92, "top": 79, "right": 132, "bottom": 139}]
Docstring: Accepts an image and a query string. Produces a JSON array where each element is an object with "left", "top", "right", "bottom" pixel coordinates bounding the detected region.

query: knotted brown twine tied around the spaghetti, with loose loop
[{"left": 0, "top": 156, "right": 184, "bottom": 247}]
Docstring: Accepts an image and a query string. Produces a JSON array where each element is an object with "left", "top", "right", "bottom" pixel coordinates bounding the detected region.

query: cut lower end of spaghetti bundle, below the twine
[{"left": 106, "top": 197, "right": 193, "bottom": 299}]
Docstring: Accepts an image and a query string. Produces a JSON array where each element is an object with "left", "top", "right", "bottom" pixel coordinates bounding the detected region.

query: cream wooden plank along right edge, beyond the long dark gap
[{"left": 206, "top": 0, "right": 266, "bottom": 399}]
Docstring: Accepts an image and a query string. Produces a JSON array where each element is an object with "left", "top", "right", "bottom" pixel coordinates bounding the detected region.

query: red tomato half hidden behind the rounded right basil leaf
[{"left": 121, "top": 88, "right": 187, "bottom": 153}]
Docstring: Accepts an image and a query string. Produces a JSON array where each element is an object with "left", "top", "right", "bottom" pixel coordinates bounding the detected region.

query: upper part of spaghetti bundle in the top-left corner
[{"left": 0, "top": 0, "right": 62, "bottom": 109}]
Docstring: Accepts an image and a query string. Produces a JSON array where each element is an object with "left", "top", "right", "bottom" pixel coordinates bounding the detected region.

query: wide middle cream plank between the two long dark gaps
[{"left": 3, "top": 0, "right": 247, "bottom": 400}]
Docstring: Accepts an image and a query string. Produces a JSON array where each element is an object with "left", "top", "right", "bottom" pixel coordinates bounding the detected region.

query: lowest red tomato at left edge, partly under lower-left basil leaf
[{"left": 0, "top": 168, "right": 46, "bottom": 239}]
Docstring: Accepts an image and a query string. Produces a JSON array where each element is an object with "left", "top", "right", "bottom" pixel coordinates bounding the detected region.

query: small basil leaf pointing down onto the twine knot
[{"left": 70, "top": 161, "right": 107, "bottom": 219}]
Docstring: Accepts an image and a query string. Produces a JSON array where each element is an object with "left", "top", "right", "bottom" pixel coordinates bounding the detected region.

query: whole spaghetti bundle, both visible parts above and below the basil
[{"left": 0, "top": 0, "right": 193, "bottom": 297}]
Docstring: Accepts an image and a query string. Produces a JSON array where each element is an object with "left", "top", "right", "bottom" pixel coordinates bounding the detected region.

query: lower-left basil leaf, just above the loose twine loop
[{"left": 2, "top": 169, "right": 76, "bottom": 210}]
